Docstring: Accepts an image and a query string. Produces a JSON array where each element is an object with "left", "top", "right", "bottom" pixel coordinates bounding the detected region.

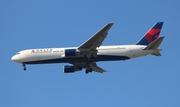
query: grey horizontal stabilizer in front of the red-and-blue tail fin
[{"left": 144, "top": 36, "right": 164, "bottom": 50}]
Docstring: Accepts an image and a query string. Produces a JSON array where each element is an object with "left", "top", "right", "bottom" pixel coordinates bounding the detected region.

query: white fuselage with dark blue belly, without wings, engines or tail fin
[{"left": 12, "top": 45, "right": 161, "bottom": 64}]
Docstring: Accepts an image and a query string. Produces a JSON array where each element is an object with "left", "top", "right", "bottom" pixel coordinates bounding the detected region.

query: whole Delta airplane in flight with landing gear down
[{"left": 11, "top": 22, "right": 164, "bottom": 74}]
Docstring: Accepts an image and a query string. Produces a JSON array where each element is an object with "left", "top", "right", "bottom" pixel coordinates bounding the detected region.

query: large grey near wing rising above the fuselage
[{"left": 78, "top": 23, "right": 114, "bottom": 50}]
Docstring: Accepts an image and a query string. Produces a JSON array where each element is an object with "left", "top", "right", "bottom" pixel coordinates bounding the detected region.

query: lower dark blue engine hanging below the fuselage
[{"left": 64, "top": 65, "right": 82, "bottom": 73}]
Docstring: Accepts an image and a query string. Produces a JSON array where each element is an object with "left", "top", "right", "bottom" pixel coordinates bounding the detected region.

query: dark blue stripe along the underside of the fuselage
[{"left": 24, "top": 55, "right": 130, "bottom": 64}]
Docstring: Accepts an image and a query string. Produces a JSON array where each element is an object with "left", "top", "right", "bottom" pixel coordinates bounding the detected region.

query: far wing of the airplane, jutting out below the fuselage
[{"left": 73, "top": 62, "right": 107, "bottom": 73}]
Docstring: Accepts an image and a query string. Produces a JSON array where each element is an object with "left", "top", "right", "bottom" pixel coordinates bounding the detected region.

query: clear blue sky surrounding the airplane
[{"left": 0, "top": 0, "right": 180, "bottom": 107}]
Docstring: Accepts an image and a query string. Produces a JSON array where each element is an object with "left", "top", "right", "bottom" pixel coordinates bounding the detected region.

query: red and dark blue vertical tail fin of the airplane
[{"left": 136, "top": 22, "right": 164, "bottom": 45}]
